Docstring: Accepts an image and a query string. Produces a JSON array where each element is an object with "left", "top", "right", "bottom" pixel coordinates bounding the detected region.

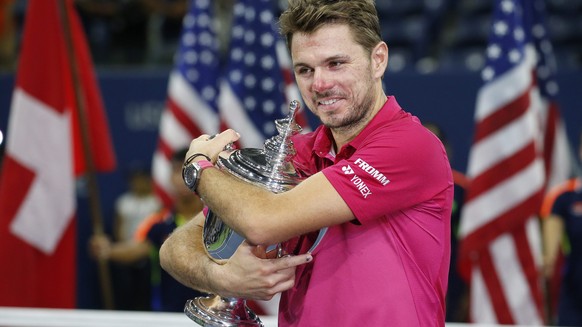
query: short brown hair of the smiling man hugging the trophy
[{"left": 279, "top": 0, "right": 382, "bottom": 52}]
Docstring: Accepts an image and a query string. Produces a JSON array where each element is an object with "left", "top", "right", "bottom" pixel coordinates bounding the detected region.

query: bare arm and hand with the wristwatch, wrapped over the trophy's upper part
[{"left": 187, "top": 130, "right": 354, "bottom": 244}]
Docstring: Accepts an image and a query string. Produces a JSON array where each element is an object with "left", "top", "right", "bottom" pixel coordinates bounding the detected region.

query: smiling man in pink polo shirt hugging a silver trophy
[{"left": 160, "top": 0, "right": 453, "bottom": 326}]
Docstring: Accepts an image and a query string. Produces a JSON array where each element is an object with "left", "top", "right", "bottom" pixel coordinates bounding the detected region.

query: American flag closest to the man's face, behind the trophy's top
[{"left": 219, "top": 0, "right": 306, "bottom": 147}]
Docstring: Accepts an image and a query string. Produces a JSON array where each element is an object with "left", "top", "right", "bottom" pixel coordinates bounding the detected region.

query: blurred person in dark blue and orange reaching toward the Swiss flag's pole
[{"left": 90, "top": 149, "right": 208, "bottom": 312}]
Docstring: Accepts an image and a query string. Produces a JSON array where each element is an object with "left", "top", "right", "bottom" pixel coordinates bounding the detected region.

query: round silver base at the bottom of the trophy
[{"left": 184, "top": 295, "right": 264, "bottom": 327}]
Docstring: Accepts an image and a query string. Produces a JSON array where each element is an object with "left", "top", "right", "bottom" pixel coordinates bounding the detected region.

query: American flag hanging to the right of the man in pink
[{"left": 460, "top": 0, "right": 572, "bottom": 325}]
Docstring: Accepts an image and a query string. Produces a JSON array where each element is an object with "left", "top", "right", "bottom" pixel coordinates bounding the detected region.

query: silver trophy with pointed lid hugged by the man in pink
[{"left": 184, "top": 101, "right": 322, "bottom": 327}]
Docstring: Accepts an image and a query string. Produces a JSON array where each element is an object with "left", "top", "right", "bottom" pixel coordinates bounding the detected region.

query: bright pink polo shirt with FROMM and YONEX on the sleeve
[{"left": 279, "top": 97, "right": 453, "bottom": 327}]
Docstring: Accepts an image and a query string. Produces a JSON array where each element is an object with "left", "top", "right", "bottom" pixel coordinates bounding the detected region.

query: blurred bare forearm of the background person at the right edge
[{"left": 542, "top": 214, "right": 564, "bottom": 278}]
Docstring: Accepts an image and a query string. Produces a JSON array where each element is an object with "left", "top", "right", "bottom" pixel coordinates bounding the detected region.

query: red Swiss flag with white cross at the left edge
[{"left": 0, "top": 0, "right": 115, "bottom": 308}]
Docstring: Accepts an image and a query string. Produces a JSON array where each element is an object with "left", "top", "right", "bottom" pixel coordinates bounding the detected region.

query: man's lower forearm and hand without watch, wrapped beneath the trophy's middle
[{"left": 160, "top": 214, "right": 312, "bottom": 300}]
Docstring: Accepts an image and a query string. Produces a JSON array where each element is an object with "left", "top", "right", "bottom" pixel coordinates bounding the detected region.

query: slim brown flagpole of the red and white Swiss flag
[{"left": 59, "top": 0, "right": 114, "bottom": 310}]
